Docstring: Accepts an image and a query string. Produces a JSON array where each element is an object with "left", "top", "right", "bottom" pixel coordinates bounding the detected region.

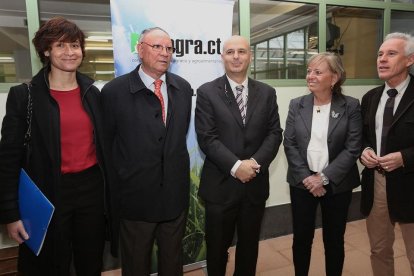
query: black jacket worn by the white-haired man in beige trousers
[{"left": 361, "top": 75, "right": 414, "bottom": 223}]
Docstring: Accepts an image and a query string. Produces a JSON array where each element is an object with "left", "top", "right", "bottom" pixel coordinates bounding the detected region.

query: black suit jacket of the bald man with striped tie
[{"left": 195, "top": 75, "right": 282, "bottom": 204}]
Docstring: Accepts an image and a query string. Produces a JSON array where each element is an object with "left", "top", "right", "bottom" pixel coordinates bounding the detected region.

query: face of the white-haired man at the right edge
[{"left": 377, "top": 38, "right": 414, "bottom": 87}]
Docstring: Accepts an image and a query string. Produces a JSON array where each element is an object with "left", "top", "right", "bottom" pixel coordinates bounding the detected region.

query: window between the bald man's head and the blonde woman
[{"left": 250, "top": 1, "right": 318, "bottom": 79}]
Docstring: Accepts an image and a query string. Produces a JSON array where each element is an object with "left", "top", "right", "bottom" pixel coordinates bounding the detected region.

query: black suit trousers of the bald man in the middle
[{"left": 205, "top": 198, "right": 265, "bottom": 276}]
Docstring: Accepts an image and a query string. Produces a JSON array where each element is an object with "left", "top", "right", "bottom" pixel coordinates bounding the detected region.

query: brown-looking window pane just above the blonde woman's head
[{"left": 327, "top": 6, "right": 383, "bottom": 79}]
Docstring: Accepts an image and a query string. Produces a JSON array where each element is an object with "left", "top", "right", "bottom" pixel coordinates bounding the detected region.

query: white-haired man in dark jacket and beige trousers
[{"left": 361, "top": 33, "right": 414, "bottom": 276}]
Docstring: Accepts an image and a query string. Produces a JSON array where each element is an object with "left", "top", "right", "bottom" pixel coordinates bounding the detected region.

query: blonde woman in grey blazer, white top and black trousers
[{"left": 283, "top": 53, "right": 362, "bottom": 276}]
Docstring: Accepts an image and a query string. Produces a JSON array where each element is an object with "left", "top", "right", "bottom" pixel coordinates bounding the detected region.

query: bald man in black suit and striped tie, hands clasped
[{"left": 195, "top": 36, "right": 282, "bottom": 276}]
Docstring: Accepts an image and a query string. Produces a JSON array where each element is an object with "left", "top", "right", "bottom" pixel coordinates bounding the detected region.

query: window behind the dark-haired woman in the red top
[{"left": 39, "top": 0, "right": 115, "bottom": 81}]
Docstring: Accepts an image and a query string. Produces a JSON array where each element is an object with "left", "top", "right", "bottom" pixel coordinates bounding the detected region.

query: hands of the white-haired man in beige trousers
[{"left": 361, "top": 148, "right": 404, "bottom": 174}]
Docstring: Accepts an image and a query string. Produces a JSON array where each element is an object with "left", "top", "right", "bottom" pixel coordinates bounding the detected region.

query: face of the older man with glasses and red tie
[{"left": 137, "top": 30, "right": 172, "bottom": 79}]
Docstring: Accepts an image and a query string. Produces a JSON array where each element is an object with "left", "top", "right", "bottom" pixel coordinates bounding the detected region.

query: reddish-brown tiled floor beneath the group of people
[{"left": 102, "top": 220, "right": 412, "bottom": 276}]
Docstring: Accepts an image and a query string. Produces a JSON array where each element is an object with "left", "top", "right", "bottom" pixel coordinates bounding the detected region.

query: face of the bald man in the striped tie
[{"left": 221, "top": 36, "right": 251, "bottom": 81}]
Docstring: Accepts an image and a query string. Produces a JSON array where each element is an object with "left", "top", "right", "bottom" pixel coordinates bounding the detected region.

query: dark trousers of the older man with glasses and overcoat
[{"left": 120, "top": 210, "right": 187, "bottom": 276}]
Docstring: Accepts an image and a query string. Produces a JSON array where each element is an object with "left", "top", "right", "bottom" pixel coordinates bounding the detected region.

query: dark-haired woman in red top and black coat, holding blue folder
[{"left": 0, "top": 17, "right": 105, "bottom": 276}]
